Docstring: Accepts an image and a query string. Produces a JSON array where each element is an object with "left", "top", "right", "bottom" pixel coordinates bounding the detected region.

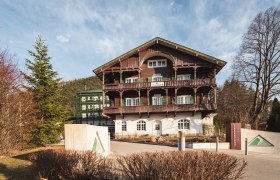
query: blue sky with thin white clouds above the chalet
[{"left": 0, "top": 0, "right": 280, "bottom": 84}]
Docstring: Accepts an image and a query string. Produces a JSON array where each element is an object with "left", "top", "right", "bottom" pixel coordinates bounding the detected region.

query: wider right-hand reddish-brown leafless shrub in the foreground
[{"left": 118, "top": 151, "right": 247, "bottom": 180}]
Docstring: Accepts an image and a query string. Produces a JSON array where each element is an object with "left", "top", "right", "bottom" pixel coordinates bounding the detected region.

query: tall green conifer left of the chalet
[{"left": 25, "top": 36, "right": 65, "bottom": 144}]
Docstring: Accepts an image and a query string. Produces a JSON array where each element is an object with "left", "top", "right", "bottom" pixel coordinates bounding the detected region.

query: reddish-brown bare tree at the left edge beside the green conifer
[{"left": 0, "top": 51, "right": 35, "bottom": 154}]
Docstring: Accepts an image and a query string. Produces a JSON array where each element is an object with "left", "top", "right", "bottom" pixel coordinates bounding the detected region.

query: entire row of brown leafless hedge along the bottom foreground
[{"left": 29, "top": 150, "right": 247, "bottom": 180}]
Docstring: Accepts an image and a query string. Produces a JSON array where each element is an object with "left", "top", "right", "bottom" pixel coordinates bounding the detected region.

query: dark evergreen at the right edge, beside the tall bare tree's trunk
[{"left": 267, "top": 98, "right": 280, "bottom": 132}]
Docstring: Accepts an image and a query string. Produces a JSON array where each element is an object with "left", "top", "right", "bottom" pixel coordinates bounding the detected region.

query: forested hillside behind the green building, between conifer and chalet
[{"left": 61, "top": 76, "right": 102, "bottom": 119}]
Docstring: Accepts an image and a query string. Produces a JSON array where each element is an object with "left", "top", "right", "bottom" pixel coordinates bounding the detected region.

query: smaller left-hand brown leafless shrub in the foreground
[{"left": 30, "top": 150, "right": 113, "bottom": 179}]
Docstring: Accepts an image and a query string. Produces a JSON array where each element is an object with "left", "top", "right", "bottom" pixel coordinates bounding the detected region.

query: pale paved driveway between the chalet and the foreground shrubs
[{"left": 111, "top": 141, "right": 280, "bottom": 180}]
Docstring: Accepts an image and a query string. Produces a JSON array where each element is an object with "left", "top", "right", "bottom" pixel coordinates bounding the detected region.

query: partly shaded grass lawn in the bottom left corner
[{"left": 0, "top": 146, "right": 64, "bottom": 180}]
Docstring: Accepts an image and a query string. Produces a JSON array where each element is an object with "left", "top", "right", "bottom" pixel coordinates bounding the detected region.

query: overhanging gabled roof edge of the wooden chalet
[{"left": 93, "top": 37, "right": 227, "bottom": 78}]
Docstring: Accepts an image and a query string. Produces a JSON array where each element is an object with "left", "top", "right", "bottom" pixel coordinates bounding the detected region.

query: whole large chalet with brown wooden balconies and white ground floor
[{"left": 93, "top": 37, "right": 226, "bottom": 136}]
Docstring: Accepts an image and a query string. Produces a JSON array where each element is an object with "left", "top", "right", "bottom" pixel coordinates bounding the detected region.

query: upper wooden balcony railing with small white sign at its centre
[{"left": 104, "top": 78, "right": 216, "bottom": 91}]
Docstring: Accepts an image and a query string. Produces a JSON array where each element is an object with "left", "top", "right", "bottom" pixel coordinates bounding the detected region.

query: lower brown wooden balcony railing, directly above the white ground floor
[{"left": 103, "top": 103, "right": 217, "bottom": 114}]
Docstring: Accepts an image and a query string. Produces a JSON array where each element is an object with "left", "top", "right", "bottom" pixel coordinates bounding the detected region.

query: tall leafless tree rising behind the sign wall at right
[{"left": 233, "top": 8, "right": 280, "bottom": 129}]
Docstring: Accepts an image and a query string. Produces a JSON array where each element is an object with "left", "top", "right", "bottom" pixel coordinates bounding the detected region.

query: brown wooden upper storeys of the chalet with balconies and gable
[{"left": 94, "top": 37, "right": 226, "bottom": 116}]
